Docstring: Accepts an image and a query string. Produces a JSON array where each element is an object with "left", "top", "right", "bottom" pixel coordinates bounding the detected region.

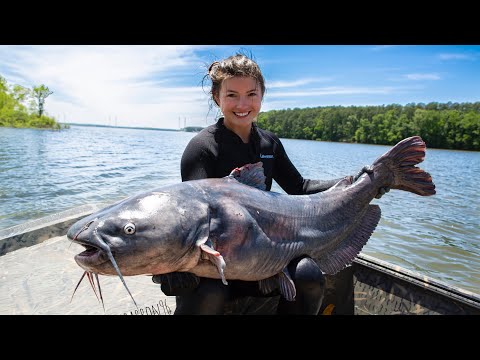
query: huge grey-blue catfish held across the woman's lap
[{"left": 67, "top": 136, "right": 435, "bottom": 306}]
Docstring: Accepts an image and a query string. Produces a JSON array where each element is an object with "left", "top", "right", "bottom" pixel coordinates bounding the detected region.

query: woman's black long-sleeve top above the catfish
[{"left": 180, "top": 118, "right": 340, "bottom": 195}]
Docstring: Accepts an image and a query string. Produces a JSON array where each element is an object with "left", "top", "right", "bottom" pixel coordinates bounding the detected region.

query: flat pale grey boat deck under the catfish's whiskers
[{"left": 0, "top": 236, "right": 175, "bottom": 315}]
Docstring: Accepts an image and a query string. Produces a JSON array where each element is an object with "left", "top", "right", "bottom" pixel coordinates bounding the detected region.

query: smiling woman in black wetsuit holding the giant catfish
[{"left": 153, "top": 54, "right": 386, "bottom": 315}]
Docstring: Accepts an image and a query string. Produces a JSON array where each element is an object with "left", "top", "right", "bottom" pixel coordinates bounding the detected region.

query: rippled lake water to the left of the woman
[{"left": 0, "top": 126, "right": 193, "bottom": 229}]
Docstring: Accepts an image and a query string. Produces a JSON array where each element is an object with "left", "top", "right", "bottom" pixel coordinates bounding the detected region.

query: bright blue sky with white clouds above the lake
[{"left": 0, "top": 45, "right": 480, "bottom": 129}]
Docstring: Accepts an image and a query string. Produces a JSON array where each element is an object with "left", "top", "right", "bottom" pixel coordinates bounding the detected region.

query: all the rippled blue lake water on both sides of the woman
[{"left": 0, "top": 126, "right": 480, "bottom": 293}]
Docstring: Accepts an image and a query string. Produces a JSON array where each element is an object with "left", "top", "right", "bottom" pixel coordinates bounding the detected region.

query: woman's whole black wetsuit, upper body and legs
[{"left": 160, "top": 118, "right": 340, "bottom": 314}]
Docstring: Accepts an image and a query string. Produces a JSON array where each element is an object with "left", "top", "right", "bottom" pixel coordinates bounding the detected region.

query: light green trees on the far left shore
[{"left": 0, "top": 75, "right": 62, "bottom": 129}]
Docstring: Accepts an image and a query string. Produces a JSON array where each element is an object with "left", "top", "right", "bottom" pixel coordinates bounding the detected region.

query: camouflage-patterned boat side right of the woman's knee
[{"left": 321, "top": 254, "right": 480, "bottom": 315}]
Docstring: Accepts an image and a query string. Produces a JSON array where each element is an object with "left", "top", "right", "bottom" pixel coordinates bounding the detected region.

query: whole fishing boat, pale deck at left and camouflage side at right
[{"left": 0, "top": 204, "right": 480, "bottom": 315}]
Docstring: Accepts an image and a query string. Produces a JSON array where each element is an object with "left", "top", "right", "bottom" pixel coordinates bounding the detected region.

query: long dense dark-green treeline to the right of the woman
[{"left": 258, "top": 102, "right": 480, "bottom": 151}]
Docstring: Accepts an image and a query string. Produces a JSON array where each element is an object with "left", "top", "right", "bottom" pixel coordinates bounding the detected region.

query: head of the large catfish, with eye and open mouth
[{"left": 67, "top": 191, "right": 208, "bottom": 276}]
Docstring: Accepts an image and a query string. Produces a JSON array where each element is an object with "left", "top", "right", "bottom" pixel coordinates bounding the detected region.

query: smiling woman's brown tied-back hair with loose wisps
[{"left": 204, "top": 53, "right": 265, "bottom": 106}]
